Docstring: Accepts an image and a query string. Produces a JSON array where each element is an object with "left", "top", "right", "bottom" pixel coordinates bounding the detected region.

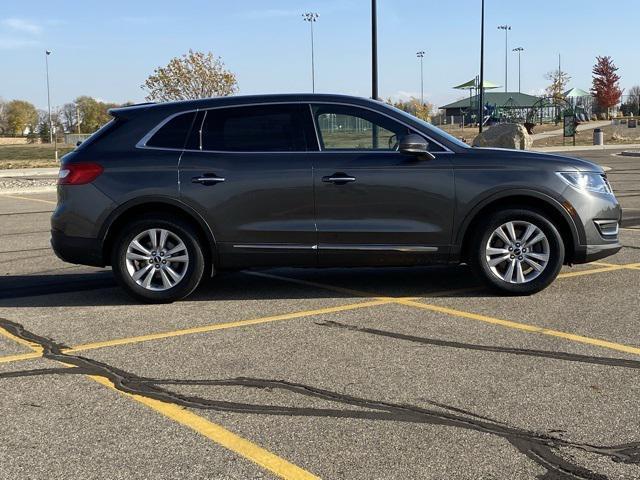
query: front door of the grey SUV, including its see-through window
[{"left": 311, "top": 103, "right": 454, "bottom": 266}]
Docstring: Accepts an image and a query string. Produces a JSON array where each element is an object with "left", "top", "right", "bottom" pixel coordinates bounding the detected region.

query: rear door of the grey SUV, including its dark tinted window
[{"left": 179, "top": 104, "right": 316, "bottom": 268}]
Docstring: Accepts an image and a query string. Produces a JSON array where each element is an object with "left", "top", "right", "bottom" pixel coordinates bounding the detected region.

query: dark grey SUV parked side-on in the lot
[{"left": 51, "top": 95, "right": 621, "bottom": 302}]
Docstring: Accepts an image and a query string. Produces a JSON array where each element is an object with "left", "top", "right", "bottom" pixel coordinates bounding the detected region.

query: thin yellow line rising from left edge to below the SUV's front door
[{"left": 0, "top": 298, "right": 394, "bottom": 363}]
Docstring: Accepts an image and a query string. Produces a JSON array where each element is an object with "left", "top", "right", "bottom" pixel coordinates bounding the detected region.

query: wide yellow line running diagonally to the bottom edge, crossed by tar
[{"left": 0, "top": 327, "right": 319, "bottom": 480}]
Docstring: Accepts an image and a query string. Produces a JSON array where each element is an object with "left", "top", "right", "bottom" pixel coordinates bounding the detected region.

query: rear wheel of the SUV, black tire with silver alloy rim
[{"left": 111, "top": 216, "right": 205, "bottom": 303}]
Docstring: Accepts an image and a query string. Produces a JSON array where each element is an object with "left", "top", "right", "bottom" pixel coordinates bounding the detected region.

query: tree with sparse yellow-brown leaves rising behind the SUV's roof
[{"left": 141, "top": 50, "right": 238, "bottom": 102}]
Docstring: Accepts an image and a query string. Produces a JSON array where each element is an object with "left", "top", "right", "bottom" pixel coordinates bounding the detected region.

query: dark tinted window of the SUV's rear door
[{"left": 202, "top": 105, "right": 307, "bottom": 152}]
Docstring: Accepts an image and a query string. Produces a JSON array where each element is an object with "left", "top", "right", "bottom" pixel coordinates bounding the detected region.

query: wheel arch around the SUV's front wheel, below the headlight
[{"left": 455, "top": 189, "right": 585, "bottom": 263}]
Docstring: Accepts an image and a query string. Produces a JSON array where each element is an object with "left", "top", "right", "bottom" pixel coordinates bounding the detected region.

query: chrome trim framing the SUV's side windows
[{"left": 135, "top": 100, "right": 455, "bottom": 155}]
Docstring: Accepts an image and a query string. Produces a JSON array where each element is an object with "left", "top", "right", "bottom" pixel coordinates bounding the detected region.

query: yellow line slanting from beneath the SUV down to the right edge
[{"left": 258, "top": 274, "right": 640, "bottom": 355}]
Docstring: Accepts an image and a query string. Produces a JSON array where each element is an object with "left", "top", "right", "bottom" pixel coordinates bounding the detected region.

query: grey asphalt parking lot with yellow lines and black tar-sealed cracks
[{"left": 0, "top": 152, "right": 640, "bottom": 480}]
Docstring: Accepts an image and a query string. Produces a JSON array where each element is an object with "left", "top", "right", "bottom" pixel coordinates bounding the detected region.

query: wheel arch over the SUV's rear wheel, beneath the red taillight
[{"left": 99, "top": 197, "right": 219, "bottom": 273}]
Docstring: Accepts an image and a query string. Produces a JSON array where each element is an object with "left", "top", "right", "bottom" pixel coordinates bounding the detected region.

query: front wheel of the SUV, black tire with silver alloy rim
[{"left": 469, "top": 208, "right": 565, "bottom": 295}]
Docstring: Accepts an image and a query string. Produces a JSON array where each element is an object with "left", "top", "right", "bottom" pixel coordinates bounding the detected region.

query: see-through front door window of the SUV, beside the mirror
[{"left": 313, "top": 105, "right": 409, "bottom": 151}]
